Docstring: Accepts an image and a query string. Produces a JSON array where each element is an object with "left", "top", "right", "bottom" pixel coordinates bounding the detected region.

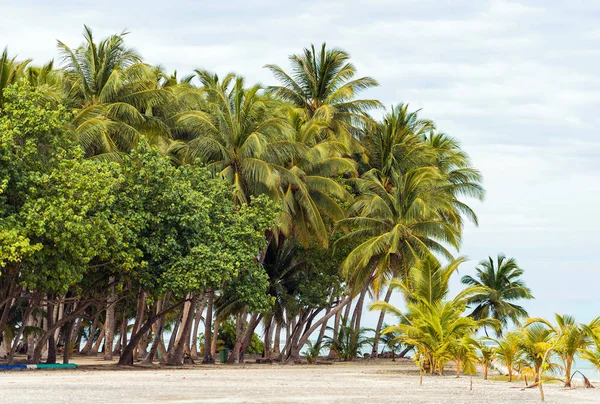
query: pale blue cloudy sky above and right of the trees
[{"left": 0, "top": 0, "right": 600, "bottom": 326}]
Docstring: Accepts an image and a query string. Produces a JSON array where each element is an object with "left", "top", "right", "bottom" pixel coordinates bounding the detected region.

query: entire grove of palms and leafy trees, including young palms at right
[{"left": 0, "top": 27, "right": 600, "bottom": 400}]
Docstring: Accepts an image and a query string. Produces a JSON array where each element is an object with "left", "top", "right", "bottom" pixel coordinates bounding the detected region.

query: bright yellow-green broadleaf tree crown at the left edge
[{"left": 0, "top": 84, "right": 116, "bottom": 293}]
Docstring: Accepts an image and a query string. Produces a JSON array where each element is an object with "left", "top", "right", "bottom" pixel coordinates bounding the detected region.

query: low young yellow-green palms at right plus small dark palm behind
[{"left": 371, "top": 254, "right": 600, "bottom": 401}]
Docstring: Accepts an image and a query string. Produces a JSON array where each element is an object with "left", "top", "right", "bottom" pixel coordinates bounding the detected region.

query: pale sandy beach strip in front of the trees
[{"left": 0, "top": 360, "right": 600, "bottom": 404}]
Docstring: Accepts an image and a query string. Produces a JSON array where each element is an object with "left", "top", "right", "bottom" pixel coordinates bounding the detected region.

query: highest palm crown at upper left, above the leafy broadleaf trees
[{"left": 58, "top": 26, "right": 170, "bottom": 158}]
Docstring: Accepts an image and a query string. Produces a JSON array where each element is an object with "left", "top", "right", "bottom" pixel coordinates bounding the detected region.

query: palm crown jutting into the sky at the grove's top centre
[{"left": 265, "top": 43, "right": 381, "bottom": 151}]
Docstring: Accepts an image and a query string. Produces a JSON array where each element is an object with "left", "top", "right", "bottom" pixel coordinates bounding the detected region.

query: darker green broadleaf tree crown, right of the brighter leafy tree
[{"left": 117, "top": 144, "right": 274, "bottom": 364}]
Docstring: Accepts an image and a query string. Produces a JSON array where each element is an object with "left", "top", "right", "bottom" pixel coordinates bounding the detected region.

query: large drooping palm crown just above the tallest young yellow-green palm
[{"left": 340, "top": 167, "right": 461, "bottom": 293}]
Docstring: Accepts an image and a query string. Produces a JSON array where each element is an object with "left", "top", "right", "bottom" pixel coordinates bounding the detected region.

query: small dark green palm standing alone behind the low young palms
[{"left": 462, "top": 254, "right": 533, "bottom": 336}]
